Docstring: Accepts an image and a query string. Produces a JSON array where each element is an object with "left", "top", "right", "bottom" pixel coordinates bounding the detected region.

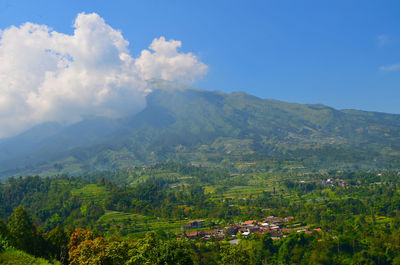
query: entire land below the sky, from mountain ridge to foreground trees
[{"left": 0, "top": 71, "right": 400, "bottom": 265}]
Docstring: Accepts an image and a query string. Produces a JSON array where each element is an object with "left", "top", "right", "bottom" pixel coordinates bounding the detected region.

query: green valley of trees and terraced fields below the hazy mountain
[{"left": 0, "top": 163, "right": 400, "bottom": 264}]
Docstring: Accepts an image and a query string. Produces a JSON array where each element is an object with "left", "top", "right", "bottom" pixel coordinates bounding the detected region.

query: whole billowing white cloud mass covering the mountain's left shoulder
[{"left": 0, "top": 13, "right": 207, "bottom": 138}]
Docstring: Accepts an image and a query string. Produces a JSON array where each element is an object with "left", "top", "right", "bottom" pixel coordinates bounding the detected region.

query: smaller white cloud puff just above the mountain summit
[{"left": 135, "top": 37, "right": 207, "bottom": 83}]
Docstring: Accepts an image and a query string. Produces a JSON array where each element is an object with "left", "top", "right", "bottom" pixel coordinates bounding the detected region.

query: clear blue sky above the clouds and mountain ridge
[{"left": 0, "top": 0, "right": 400, "bottom": 113}]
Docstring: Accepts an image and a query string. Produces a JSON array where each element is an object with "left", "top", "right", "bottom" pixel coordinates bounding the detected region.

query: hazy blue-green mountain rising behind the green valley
[{"left": 0, "top": 80, "right": 400, "bottom": 176}]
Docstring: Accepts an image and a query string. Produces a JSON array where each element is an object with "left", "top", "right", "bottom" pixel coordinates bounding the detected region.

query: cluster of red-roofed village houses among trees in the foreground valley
[{"left": 180, "top": 216, "right": 321, "bottom": 240}]
